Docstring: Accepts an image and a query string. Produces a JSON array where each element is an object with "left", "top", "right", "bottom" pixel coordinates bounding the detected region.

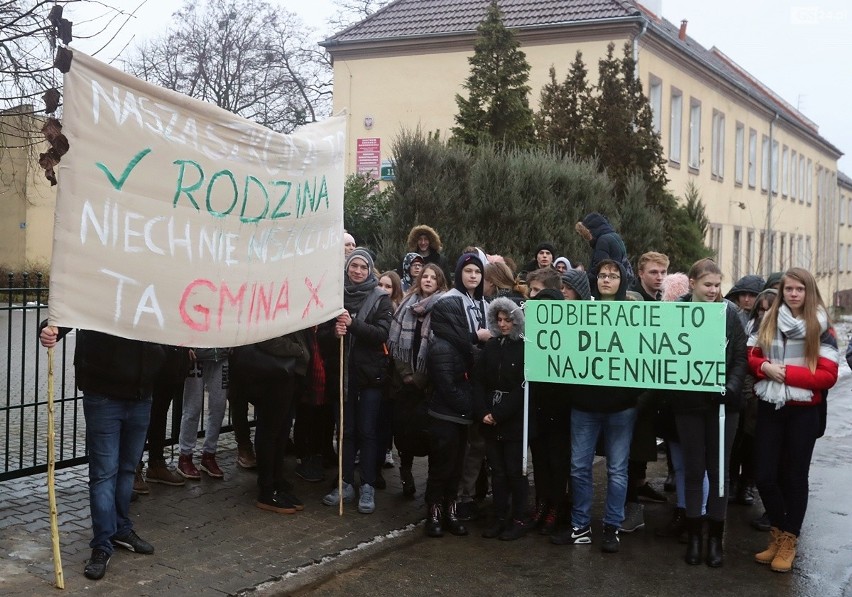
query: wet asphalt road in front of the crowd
[{"left": 302, "top": 367, "right": 852, "bottom": 597}]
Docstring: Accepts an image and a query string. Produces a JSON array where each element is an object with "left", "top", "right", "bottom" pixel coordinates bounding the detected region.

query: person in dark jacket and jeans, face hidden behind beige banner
[{"left": 39, "top": 322, "right": 166, "bottom": 580}]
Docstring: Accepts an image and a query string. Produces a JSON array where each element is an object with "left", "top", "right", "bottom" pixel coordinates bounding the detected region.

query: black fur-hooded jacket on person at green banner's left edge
[{"left": 473, "top": 297, "right": 524, "bottom": 441}]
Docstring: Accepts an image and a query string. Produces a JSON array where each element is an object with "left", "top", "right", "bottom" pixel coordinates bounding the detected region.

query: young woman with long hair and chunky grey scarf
[{"left": 388, "top": 263, "right": 447, "bottom": 498}]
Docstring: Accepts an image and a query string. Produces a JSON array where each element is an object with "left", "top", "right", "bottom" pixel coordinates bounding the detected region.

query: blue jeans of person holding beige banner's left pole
[{"left": 83, "top": 394, "right": 151, "bottom": 554}]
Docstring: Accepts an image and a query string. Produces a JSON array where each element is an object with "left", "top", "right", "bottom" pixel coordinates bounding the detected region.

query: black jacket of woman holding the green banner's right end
[{"left": 665, "top": 294, "right": 748, "bottom": 414}]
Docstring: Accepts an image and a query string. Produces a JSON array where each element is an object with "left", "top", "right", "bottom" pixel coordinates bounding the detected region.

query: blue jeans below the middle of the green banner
[{"left": 571, "top": 408, "right": 636, "bottom": 527}]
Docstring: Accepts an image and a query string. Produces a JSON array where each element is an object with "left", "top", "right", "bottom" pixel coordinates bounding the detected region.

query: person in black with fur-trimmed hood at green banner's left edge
[{"left": 473, "top": 297, "right": 529, "bottom": 541}]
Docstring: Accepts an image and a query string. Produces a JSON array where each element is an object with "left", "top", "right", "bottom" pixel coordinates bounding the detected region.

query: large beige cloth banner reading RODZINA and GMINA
[{"left": 49, "top": 51, "right": 345, "bottom": 347}]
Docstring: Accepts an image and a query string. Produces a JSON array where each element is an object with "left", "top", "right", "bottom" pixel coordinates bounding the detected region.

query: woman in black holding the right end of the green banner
[{"left": 669, "top": 259, "right": 747, "bottom": 568}]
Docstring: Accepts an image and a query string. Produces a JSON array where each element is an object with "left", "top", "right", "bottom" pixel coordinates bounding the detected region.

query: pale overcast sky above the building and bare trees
[{"left": 67, "top": 0, "right": 852, "bottom": 176}]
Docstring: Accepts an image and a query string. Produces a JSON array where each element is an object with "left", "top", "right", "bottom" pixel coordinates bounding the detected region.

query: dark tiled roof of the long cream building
[{"left": 322, "top": 0, "right": 843, "bottom": 157}]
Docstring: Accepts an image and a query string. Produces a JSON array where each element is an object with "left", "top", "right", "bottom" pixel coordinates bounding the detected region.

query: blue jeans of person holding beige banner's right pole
[{"left": 343, "top": 376, "right": 382, "bottom": 485}]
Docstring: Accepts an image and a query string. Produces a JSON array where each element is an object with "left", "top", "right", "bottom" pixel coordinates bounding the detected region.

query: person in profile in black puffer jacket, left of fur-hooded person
[{"left": 426, "top": 298, "right": 474, "bottom": 537}]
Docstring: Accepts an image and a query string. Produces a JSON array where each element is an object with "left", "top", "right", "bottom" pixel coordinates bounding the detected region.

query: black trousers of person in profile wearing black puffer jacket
[{"left": 426, "top": 418, "right": 468, "bottom": 504}]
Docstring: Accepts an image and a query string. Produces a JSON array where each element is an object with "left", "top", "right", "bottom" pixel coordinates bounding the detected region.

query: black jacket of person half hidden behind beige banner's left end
[{"left": 48, "top": 322, "right": 166, "bottom": 400}]
